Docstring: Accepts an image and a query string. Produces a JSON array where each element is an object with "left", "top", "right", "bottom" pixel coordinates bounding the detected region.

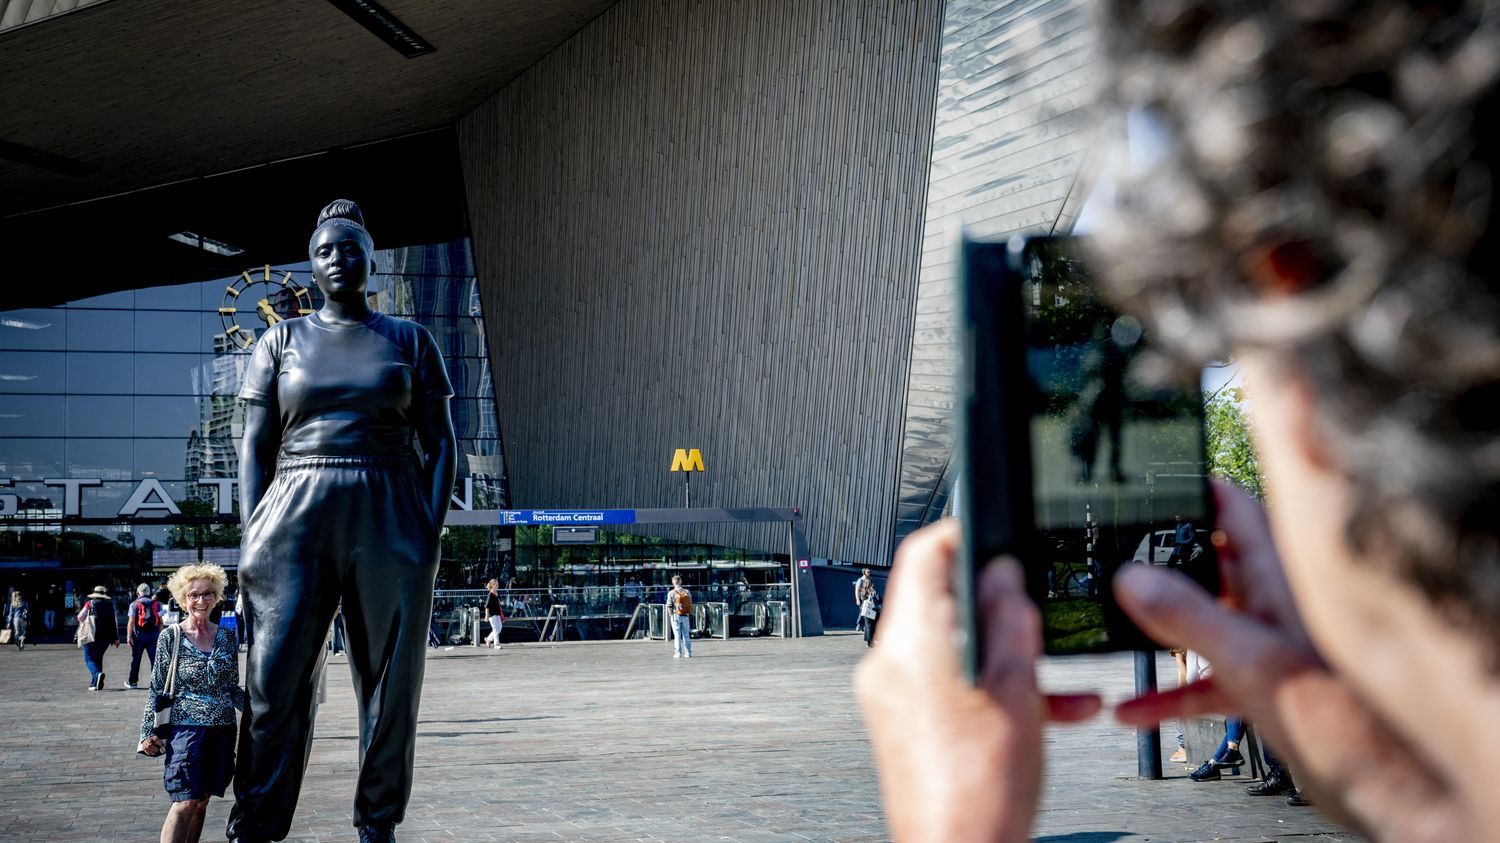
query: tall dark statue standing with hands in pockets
[{"left": 228, "top": 200, "right": 456, "bottom": 840}]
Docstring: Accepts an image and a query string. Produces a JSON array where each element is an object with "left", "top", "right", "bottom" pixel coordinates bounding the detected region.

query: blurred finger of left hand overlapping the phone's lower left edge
[{"left": 980, "top": 557, "right": 1041, "bottom": 699}]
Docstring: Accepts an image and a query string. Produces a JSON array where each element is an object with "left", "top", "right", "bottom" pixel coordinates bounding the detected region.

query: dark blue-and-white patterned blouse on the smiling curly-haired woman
[{"left": 141, "top": 624, "right": 245, "bottom": 741}]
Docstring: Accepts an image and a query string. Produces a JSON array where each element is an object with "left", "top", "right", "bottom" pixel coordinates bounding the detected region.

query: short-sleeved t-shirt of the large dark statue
[{"left": 240, "top": 314, "right": 453, "bottom": 456}]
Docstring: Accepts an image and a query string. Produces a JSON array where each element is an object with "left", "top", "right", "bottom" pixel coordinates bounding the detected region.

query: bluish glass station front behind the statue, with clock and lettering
[{"left": 0, "top": 240, "right": 510, "bottom": 603}]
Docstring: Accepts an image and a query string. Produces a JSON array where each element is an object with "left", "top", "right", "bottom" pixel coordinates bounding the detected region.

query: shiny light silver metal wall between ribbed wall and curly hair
[{"left": 894, "top": 0, "right": 1095, "bottom": 552}]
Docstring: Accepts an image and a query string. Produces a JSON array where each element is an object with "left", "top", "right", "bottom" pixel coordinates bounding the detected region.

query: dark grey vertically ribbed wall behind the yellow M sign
[{"left": 459, "top": 0, "right": 942, "bottom": 563}]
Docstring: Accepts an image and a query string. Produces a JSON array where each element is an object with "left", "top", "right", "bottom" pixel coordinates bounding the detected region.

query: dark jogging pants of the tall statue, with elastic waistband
[{"left": 228, "top": 456, "right": 438, "bottom": 840}]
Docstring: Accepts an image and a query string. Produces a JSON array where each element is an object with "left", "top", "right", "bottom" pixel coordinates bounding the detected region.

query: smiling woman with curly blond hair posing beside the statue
[{"left": 138, "top": 564, "right": 245, "bottom": 843}]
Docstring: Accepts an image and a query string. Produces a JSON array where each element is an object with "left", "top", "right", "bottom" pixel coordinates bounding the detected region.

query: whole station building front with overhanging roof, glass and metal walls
[{"left": 0, "top": 0, "right": 1092, "bottom": 621}]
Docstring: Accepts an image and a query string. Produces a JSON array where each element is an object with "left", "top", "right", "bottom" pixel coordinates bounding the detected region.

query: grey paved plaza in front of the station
[{"left": 0, "top": 633, "right": 1353, "bottom": 843}]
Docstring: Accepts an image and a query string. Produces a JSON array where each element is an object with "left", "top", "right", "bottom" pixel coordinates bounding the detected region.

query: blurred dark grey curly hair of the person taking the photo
[{"left": 1097, "top": 0, "right": 1500, "bottom": 642}]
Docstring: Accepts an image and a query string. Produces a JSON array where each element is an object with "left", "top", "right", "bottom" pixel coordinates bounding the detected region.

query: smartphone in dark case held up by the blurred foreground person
[{"left": 954, "top": 231, "right": 1220, "bottom": 678}]
